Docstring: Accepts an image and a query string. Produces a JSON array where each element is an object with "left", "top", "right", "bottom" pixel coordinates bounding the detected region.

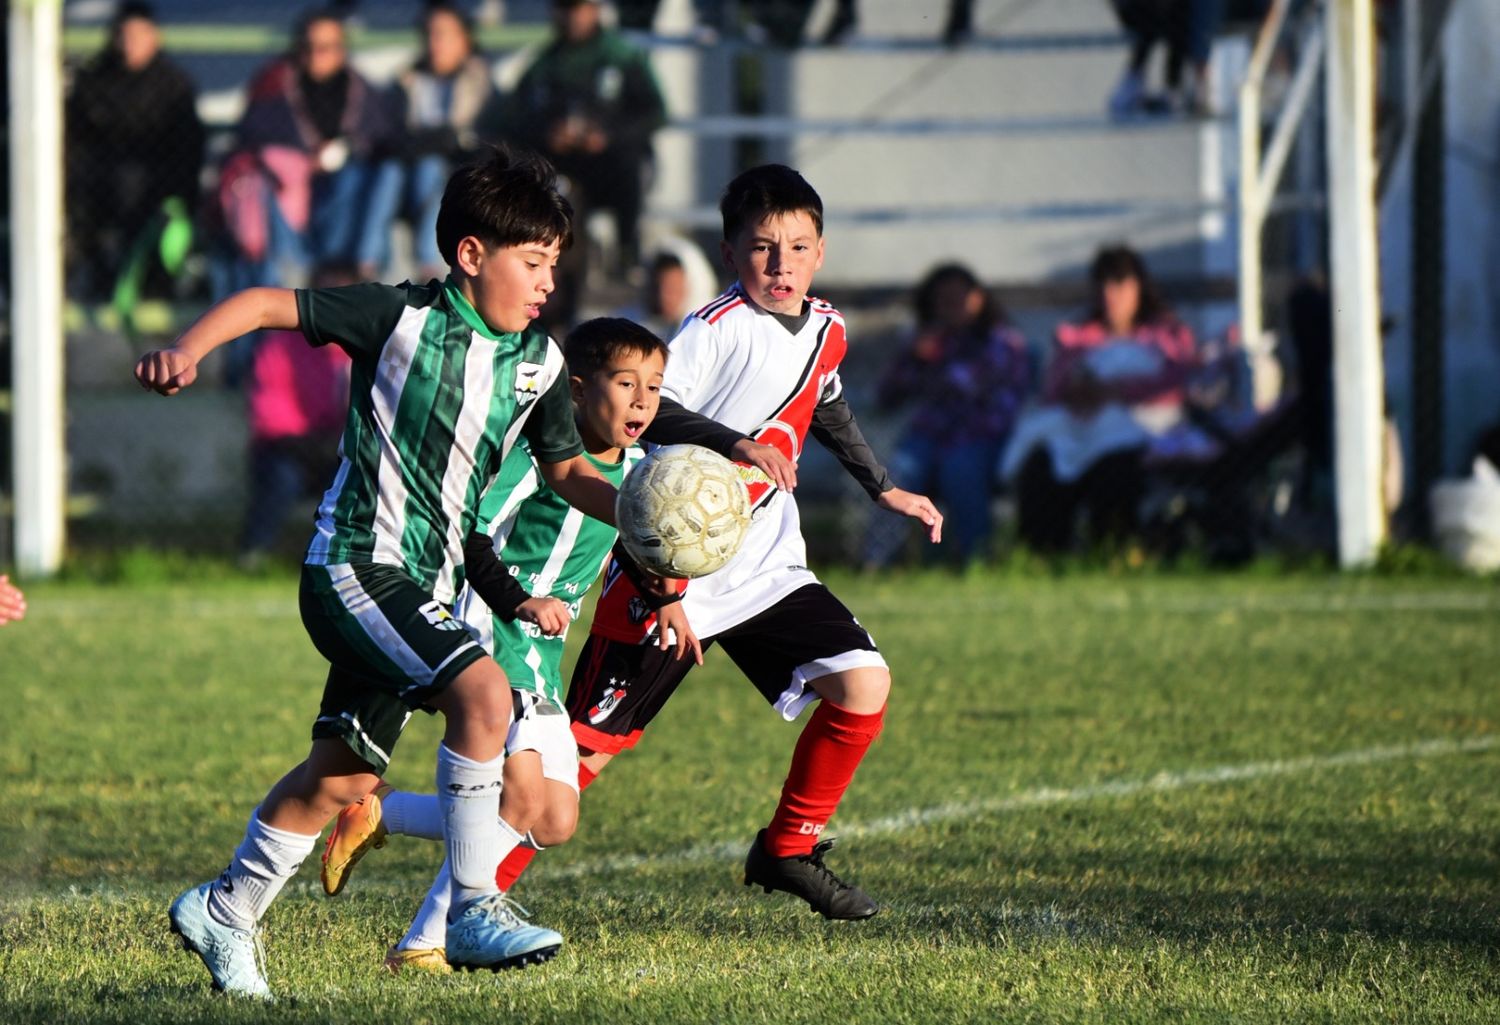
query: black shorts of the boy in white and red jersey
[{"left": 567, "top": 584, "right": 885, "bottom": 755}]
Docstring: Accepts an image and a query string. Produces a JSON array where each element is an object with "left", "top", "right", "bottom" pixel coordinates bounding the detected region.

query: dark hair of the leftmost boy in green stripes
[{"left": 438, "top": 146, "right": 573, "bottom": 267}]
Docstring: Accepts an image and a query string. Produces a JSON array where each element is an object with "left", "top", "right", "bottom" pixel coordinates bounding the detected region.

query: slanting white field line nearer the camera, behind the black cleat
[{"left": 542, "top": 734, "right": 1500, "bottom": 878}]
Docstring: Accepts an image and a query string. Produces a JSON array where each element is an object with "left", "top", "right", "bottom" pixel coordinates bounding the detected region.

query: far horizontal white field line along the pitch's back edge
[{"left": 27, "top": 590, "right": 1500, "bottom": 621}]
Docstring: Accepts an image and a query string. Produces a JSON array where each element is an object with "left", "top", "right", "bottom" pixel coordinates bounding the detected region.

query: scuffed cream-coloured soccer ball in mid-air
[{"left": 615, "top": 444, "right": 750, "bottom": 578}]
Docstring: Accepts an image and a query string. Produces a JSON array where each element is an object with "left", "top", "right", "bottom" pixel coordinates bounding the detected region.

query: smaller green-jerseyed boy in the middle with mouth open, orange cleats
[{"left": 323, "top": 318, "right": 702, "bottom": 971}]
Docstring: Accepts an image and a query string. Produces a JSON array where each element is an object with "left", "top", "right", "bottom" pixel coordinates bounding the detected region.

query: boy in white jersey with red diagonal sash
[{"left": 480, "top": 165, "right": 942, "bottom": 918}]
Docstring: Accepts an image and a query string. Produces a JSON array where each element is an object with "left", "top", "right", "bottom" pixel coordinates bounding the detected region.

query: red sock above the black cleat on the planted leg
[{"left": 765, "top": 699, "right": 885, "bottom": 858}]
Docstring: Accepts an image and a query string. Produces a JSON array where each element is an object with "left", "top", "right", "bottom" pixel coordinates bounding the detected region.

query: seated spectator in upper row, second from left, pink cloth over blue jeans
[{"left": 219, "top": 11, "right": 393, "bottom": 291}]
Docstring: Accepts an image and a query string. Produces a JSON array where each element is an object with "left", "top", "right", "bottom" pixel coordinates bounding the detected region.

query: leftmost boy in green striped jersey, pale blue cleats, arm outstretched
[{"left": 135, "top": 150, "right": 633, "bottom": 996}]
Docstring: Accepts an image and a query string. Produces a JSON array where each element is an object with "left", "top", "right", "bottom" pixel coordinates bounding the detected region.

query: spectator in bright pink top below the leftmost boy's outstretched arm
[{"left": 240, "top": 264, "right": 360, "bottom": 569}]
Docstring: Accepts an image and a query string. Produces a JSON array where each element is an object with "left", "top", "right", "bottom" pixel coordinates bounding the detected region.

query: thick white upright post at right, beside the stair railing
[{"left": 1326, "top": 0, "right": 1386, "bottom": 567}]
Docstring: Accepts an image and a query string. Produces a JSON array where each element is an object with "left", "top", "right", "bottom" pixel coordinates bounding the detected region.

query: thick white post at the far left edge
[{"left": 9, "top": 0, "right": 66, "bottom": 576}]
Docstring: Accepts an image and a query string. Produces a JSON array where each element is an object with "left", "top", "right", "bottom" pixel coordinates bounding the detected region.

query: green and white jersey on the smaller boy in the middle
[{"left": 456, "top": 443, "right": 642, "bottom": 707}]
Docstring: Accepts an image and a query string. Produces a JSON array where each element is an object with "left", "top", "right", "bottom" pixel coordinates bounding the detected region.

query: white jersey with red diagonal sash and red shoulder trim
[{"left": 662, "top": 285, "right": 848, "bottom": 636}]
